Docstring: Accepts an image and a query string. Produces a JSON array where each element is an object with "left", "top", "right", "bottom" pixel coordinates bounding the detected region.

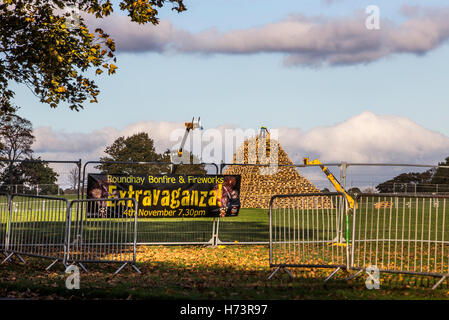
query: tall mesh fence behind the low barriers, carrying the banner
[{"left": 0, "top": 159, "right": 445, "bottom": 245}]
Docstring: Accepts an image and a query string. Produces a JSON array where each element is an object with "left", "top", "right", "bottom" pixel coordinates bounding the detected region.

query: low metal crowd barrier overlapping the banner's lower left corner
[{"left": 67, "top": 198, "right": 138, "bottom": 273}]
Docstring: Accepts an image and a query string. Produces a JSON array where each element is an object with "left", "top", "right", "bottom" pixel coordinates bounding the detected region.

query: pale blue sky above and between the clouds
[{"left": 9, "top": 0, "right": 449, "bottom": 170}]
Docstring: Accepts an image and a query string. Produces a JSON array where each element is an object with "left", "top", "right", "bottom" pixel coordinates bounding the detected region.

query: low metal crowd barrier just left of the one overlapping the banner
[{"left": 6, "top": 195, "right": 68, "bottom": 261}]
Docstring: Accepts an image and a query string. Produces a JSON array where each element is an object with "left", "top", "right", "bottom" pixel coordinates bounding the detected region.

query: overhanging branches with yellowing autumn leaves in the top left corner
[{"left": 0, "top": 0, "right": 186, "bottom": 111}]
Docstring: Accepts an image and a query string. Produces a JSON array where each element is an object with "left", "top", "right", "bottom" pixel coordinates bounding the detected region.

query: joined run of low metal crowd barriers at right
[{"left": 269, "top": 193, "right": 449, "bottom": 289}]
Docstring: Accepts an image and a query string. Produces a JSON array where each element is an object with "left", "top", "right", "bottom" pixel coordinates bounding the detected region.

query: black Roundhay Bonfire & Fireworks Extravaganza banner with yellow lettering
[{"left": 87, "top": 174, "right": 241, "bottom": 218}]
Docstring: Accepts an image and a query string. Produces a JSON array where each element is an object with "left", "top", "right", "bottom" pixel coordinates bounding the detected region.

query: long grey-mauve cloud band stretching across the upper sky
[{"left": 89, "top": 6, "right": 449, "bottom": 66}]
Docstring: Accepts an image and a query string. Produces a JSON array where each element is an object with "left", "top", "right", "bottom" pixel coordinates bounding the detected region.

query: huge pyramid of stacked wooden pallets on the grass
[{"left": 223, "top": 133, "right": 332, "bottom": 208}]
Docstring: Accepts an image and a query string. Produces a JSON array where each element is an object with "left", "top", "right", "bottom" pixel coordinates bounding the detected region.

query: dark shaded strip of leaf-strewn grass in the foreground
[{"left": 0, "top": 249, "right": 448, "bottom": 300}]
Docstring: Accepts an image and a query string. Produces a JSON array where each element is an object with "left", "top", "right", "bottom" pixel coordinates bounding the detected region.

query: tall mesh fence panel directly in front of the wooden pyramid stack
[{"left": 218, "top": 164, "right": 340, "bottom": 244}]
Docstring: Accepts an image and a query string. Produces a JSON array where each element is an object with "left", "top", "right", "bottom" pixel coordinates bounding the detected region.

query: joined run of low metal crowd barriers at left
[{"left": 0, "top": 194, "right": 140, "bottom": 273}]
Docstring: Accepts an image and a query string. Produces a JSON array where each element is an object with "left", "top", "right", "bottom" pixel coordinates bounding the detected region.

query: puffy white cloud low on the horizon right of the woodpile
[{"left": 280, "top": 112, "right": 449, "bottom": 164}]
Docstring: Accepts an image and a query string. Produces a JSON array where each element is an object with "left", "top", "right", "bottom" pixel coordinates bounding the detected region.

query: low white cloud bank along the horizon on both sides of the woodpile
[{"left": 33, "top": 111, "right": 449, "bottom": 164}]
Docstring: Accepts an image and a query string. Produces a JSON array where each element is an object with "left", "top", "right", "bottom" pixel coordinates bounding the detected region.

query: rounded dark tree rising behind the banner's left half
[{"left": 96, "top": 132, "right": 169, "bottom": 174}]
